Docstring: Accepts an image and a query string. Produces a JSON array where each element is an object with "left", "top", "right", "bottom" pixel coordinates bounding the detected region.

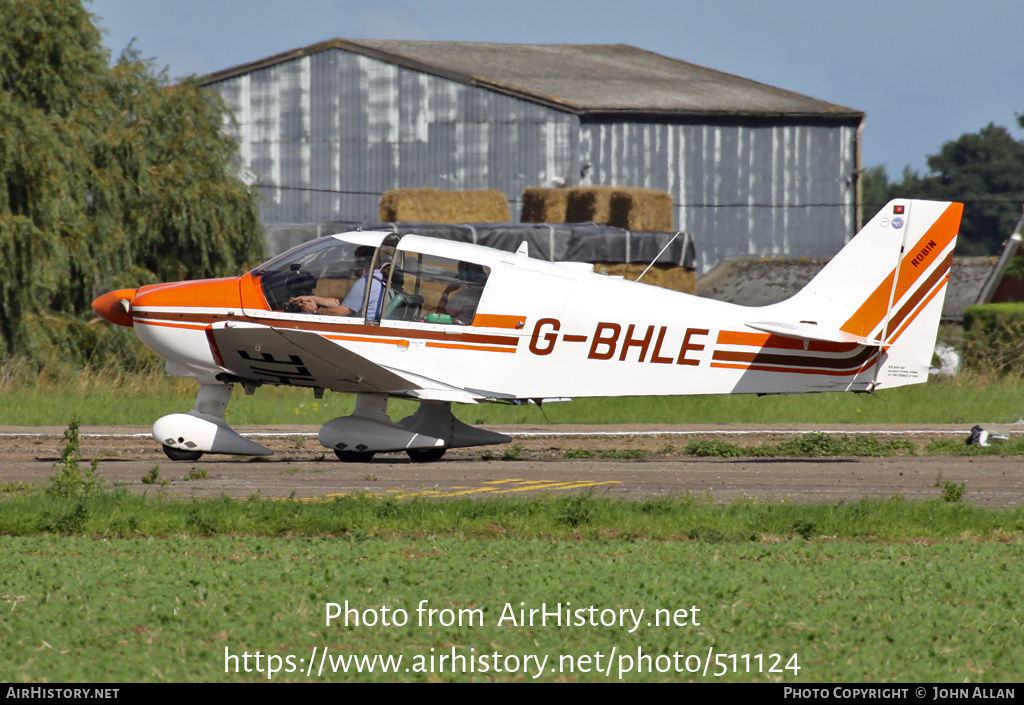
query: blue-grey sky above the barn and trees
[{"left": 86, "top": 0, "right": 1024, "bottom": 179}]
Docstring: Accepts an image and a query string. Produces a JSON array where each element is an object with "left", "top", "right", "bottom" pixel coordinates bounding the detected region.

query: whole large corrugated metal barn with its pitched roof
[{"left": 203, "top": 39, "right": 864, "bottom": 272}]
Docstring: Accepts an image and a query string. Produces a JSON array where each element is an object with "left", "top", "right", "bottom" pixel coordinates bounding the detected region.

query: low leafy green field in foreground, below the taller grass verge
[{"left": 0, "top": 536, "right": 1024, "bottom": 682}]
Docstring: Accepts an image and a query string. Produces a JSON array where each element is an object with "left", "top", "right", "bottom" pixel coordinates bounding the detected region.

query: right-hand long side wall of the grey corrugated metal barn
[{"left": 580, "top": 120, "right": 857, "bottom": 271}]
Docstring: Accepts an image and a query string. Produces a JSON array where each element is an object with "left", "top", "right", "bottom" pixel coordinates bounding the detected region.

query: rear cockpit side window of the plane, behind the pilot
[{"left": 384, "top": 252, "right": 490, "bottom": 326}]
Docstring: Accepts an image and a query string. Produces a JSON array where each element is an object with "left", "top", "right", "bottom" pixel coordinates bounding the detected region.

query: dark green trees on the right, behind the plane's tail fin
[{"left": 863, "top": 117, "right": 1024, "bottom": 255}]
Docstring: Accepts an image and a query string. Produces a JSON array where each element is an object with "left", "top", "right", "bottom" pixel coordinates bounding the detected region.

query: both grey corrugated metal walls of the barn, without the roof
[{"left": 209, "top": 49, "right": 857, "bottom": 271}]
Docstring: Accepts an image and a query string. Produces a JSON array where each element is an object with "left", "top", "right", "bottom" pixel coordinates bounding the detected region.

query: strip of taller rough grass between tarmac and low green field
[{"left": 0, "top": 483, "right": 1024, "bottom": 543}]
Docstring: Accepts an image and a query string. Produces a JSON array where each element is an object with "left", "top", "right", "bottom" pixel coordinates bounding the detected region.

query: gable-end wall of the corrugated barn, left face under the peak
[{"left": 208, "top": 49, "right": 579, "bottom": 224}]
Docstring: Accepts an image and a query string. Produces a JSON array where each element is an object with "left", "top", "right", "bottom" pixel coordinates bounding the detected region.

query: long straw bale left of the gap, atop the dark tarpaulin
[{"left": 378, "top": 189, "right": 512, "bottom": 223}]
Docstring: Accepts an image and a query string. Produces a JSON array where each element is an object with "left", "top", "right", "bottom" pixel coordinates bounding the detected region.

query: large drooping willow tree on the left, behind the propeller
[{"left": 0, "top": 0, "right": 263, "bottom": 366}]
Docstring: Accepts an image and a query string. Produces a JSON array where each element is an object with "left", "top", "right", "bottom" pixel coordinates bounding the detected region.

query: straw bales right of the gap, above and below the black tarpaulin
[{"left": 521, "top": 186, "right": 697, "bottom": 294}]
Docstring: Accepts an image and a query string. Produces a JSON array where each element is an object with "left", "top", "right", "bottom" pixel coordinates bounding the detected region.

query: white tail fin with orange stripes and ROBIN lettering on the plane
[{"left": 748, "top": 200, "right": 964, "bottom": 388}]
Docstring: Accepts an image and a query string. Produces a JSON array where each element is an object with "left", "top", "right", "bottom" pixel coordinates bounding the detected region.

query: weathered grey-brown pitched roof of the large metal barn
[{"left": 203, "top": 39, "right": 864, "bottom": 120}]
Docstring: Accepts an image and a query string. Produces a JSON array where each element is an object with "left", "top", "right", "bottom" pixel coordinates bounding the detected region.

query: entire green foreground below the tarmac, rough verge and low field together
[{"left": 0, "top": 491, "right": 1024, "bottom": 682}]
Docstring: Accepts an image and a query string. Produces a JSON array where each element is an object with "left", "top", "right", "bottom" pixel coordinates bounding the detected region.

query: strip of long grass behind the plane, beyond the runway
[{"left": 0, "top": 372, "right": 1024, "bottom": 425}]
